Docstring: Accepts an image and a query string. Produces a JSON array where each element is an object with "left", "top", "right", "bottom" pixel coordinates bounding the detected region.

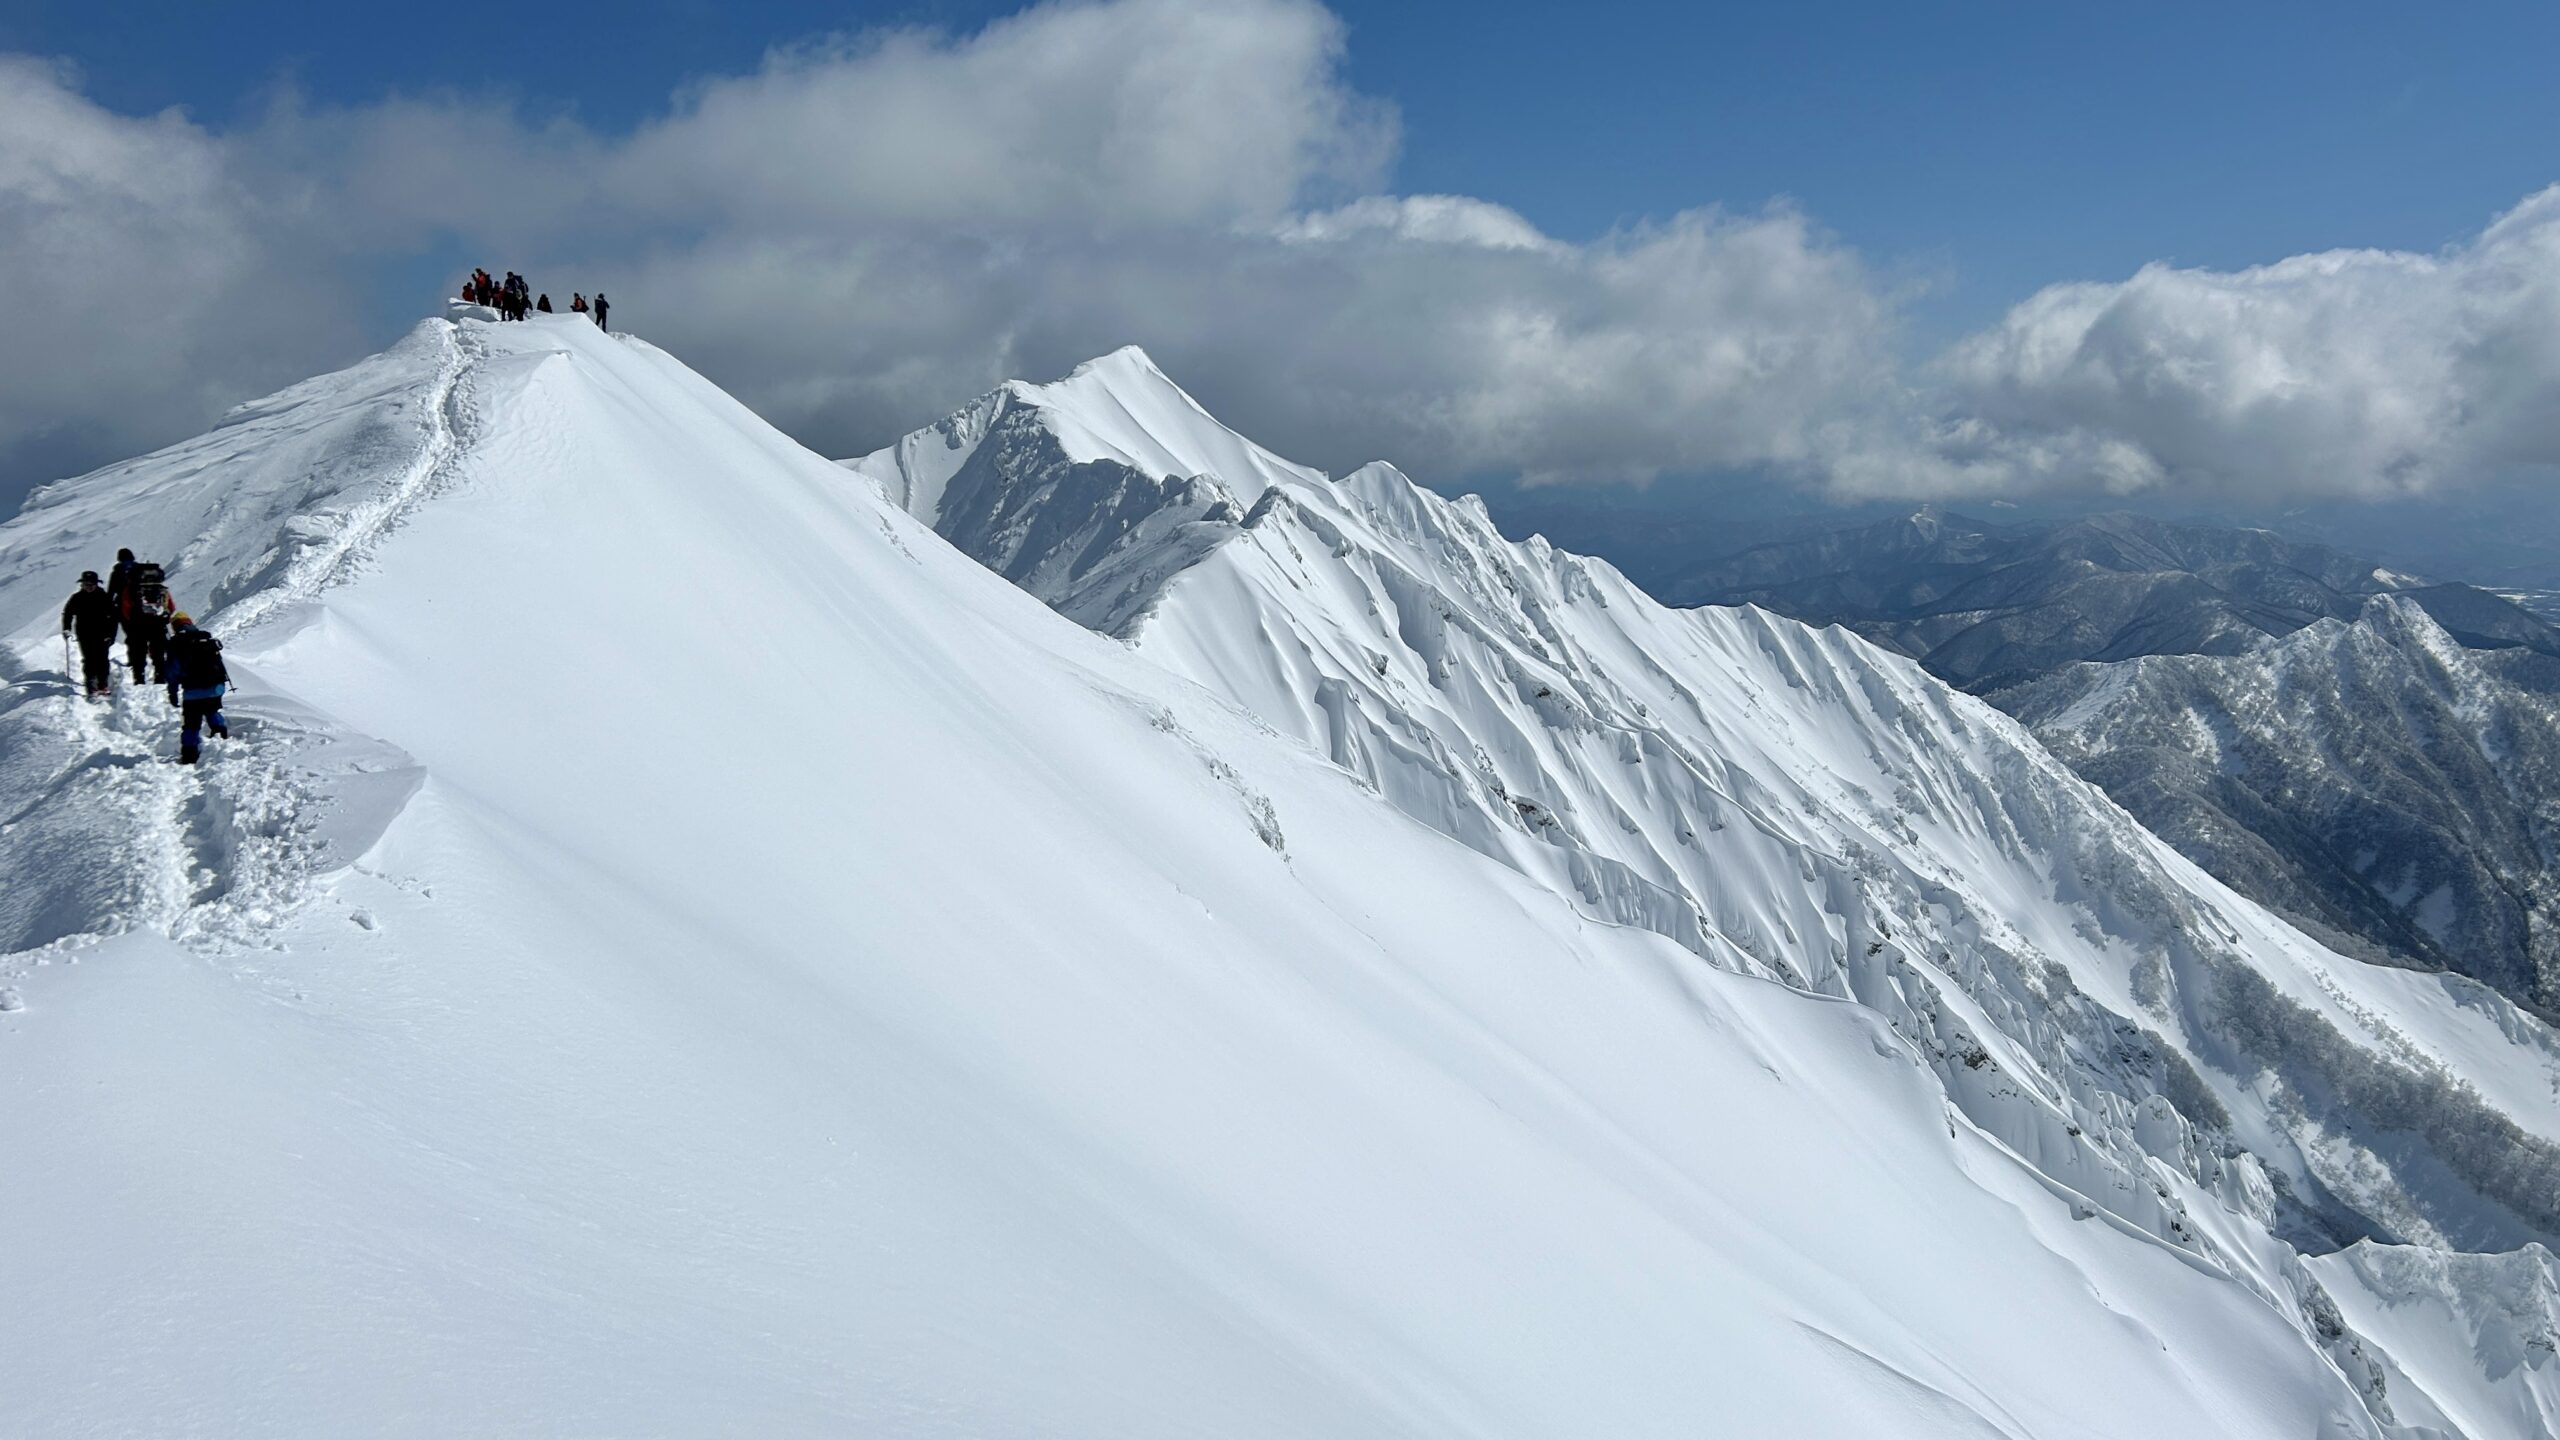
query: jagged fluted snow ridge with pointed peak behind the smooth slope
[{"left": 850, "top": 351, "right": 2560, "bottom": 1434}]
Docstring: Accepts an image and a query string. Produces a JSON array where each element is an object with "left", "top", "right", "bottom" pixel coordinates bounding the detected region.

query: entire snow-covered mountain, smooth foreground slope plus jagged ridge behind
[{"left": 0, "top": 318, "right": 2560, "bottom": 1440}]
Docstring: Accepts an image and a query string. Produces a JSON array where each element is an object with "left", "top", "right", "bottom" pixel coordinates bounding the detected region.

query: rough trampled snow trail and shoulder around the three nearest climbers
[{"left": 0, "top": 325, "right": 458, "bottom": 973}]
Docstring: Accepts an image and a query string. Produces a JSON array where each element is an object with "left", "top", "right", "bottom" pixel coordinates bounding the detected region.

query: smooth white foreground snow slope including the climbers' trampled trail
[{"left": 0, "top": 318, "right": 2388, "bottom": 1440}]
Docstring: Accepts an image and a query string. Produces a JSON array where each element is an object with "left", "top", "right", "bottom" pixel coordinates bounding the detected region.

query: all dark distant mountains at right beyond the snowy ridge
[{"left": 1597, "top": 507, "right": 2560, "bottom": 1017}]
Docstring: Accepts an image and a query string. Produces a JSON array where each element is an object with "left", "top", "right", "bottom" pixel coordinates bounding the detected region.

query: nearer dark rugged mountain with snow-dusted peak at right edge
[{"left": 1994, "top": 597, "right": 2560, "bottom": 1015}]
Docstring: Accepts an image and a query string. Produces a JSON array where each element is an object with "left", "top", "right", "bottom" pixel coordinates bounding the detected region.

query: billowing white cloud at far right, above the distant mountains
[{"left": 1938, "top": 187, "right": 2560, "bottom": 497}]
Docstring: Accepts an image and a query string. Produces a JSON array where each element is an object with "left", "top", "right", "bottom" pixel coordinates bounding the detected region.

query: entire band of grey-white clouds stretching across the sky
[{"left": 0, "top": 0, "right": 2560, "bottom": 507}]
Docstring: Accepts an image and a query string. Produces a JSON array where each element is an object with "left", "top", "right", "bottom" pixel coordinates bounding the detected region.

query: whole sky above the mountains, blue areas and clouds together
[{"left": 0, "top": 0, "right": 2560, "bottom": 515}]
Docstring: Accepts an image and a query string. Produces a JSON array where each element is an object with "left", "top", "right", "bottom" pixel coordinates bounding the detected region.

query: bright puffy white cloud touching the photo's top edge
[{"left": 609, "top": 0, "right": 1395, "bottom": 231}]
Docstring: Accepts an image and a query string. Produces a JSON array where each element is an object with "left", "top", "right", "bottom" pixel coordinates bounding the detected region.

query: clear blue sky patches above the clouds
[{"left": 20, "top": 0, "right": 2560, "bottom": 328}]
